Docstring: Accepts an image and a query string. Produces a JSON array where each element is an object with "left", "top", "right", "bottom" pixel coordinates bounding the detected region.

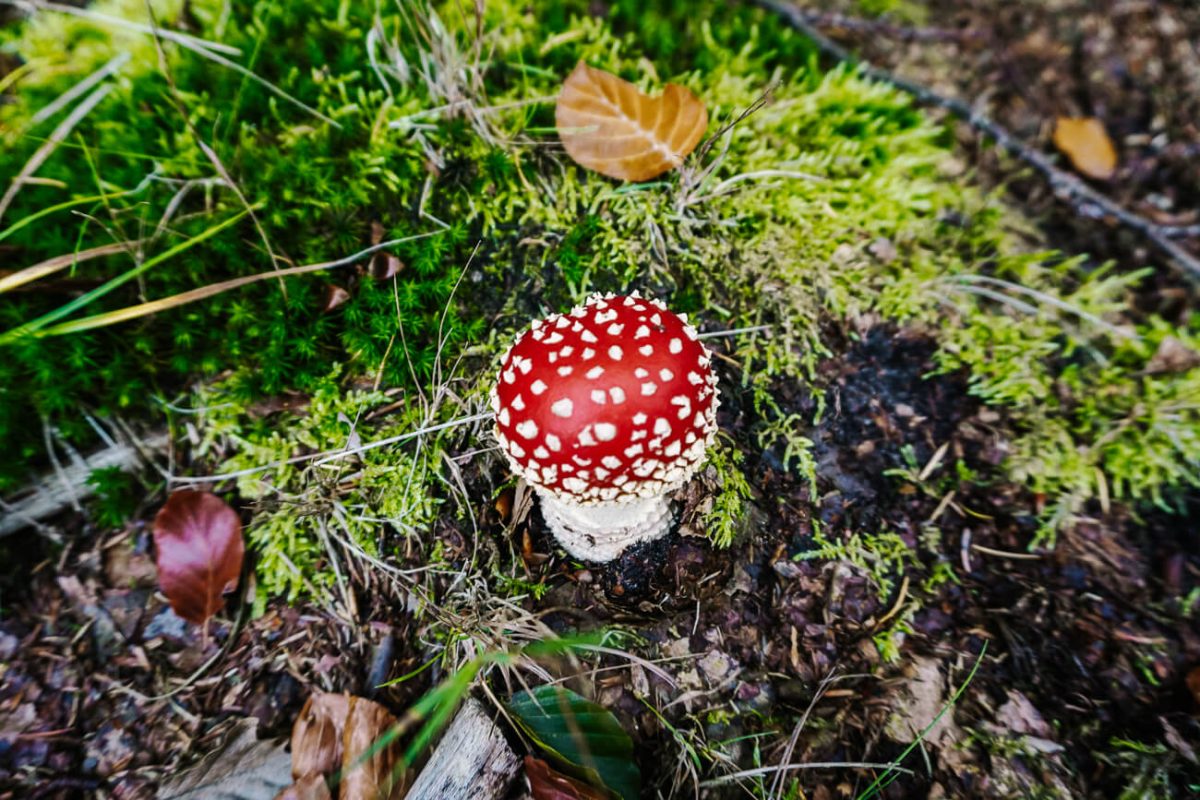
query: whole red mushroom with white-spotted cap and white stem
[{"left": 491, "top": 293, "right": 719, "bottom": 561}]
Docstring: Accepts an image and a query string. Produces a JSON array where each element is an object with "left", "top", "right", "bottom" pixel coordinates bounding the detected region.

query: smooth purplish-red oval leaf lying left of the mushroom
[{"left": 154, "top": 489, "right": 245, "bottom": 625}]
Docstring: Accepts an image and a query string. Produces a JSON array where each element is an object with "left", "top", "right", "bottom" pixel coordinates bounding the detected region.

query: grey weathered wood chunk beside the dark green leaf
[{"left": 406, "top": 699, "right": 521, "bottom": 800}]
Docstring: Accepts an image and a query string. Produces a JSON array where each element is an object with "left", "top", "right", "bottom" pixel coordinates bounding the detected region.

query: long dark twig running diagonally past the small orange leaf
[{"left": 754, "top": 0, "right": 1200, "bottom": 282}]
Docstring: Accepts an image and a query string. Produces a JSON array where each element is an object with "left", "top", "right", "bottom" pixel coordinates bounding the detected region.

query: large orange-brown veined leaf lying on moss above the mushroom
[{"left": 554, "top": 61, "right": 708, "bottom": 181}]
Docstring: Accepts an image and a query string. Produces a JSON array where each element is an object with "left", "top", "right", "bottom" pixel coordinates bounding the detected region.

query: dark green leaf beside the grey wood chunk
[{"left": 509, "top": 686, "right": 642, "bottom": 800}]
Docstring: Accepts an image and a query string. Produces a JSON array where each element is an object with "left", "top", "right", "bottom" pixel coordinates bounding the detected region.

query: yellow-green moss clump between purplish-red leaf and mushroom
[{"left": 197, "top": 368, "right": 442, "bottom": 600}]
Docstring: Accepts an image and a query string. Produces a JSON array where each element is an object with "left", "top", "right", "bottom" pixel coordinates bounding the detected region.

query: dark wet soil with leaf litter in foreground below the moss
[{"left": 0, "top": 326, "right": 1200, "bottom": 799}]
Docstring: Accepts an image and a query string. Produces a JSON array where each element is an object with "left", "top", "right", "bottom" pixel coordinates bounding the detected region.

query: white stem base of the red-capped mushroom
[{"left": 536, "top": 489, "right": 673, "bottom": 561}]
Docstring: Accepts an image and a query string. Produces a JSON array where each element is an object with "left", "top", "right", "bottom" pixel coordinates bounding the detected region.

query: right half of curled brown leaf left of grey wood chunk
[{"left": 337, "top": 697, "right": 408, "bottom": 800}]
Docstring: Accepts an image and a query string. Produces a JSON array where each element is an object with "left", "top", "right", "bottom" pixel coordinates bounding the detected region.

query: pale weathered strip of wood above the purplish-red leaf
[{"left": 0, "top": 433, "right": 169, "bottom": 536}]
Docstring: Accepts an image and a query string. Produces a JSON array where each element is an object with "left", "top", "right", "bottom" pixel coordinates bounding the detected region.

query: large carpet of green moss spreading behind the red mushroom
[{"left": 0, "top": 0, "right": 1200, "bottom": 594}]
